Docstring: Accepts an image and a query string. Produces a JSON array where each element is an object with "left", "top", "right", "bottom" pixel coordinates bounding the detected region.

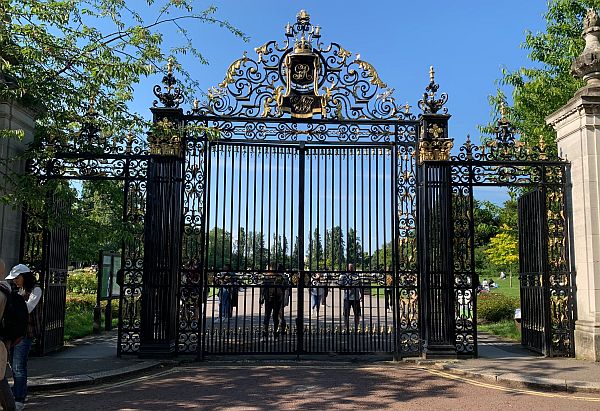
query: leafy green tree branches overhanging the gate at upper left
[{"left": 0, "top": 0, "right": 243, "bottom": 206}]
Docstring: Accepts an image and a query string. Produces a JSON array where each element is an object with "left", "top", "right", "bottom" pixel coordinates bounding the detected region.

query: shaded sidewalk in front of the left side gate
[{"left": 27, "top": 331, "right": 160, "bottom": 392}]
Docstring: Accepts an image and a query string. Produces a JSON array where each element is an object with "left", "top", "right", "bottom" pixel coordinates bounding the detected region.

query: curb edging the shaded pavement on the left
[{"left": 27, "top": 361, "right": 164, "bottom": 393}]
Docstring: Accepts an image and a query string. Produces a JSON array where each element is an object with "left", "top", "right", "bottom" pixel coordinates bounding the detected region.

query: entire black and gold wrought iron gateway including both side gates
[{"left": 23, "top": 11, "right": 574, "bottom": 358}]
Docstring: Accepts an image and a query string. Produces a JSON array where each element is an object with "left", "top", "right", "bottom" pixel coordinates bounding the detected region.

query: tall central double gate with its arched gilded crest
[{"left": 165, "top": 12, "right": 421, "bottom": 356}]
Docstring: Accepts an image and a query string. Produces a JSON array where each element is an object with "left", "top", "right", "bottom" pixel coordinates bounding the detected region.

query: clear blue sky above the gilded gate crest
[{"left": 133, "top": 0, "right": 546, "bottom": 202}]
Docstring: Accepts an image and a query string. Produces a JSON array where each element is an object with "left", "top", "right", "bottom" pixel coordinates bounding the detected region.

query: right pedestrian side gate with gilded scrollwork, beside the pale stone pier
[{"left": 449, "top": 113, "right": 575, "bottom": 356}]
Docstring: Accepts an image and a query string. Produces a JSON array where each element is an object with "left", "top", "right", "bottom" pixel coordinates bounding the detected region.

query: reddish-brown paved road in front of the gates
[{"left": 27, "top": 363, "right": 600, "bottom": 411}]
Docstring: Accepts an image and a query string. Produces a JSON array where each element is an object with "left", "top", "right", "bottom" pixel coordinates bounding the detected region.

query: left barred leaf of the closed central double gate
[{"left": 203, "top": 142, "right": 304, "bottom": 354}]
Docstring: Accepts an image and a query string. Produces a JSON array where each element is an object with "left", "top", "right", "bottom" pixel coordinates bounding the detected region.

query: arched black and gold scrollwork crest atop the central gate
[{"left": 192, "top": 11, "right": 414, "bottom": 120}]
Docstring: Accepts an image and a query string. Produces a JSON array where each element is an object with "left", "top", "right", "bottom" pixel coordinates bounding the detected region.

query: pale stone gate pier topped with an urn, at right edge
[{"left": 546, "top": 11, "right": 600, "bottom": 361}]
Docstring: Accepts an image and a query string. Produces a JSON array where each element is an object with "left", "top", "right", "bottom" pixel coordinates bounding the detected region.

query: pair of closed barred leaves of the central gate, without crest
[{"left": 197, "top": 141, "right": 419, "bottom": 355}]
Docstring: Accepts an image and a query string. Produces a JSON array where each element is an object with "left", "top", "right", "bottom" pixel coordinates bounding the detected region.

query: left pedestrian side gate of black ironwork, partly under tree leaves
[{"left": 21, "top": 124, "right": 149, "bottom": 355}]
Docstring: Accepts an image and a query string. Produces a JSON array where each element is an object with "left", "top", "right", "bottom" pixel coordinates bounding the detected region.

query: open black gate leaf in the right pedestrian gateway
[{"left": 518, "top": 190, "right": 550, "bottom": 355}]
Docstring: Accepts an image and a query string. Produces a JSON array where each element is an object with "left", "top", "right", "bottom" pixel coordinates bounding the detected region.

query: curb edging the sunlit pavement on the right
[{"left": 433, "top": 363, "right": 600, "bottom": 394}]
